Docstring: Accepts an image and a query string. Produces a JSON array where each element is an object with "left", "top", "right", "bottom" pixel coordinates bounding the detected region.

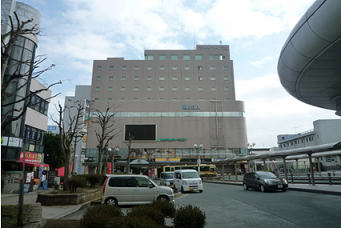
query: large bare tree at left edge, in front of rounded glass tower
[{"left": 1, "top": 13, "right": 61, "bottom": 135}]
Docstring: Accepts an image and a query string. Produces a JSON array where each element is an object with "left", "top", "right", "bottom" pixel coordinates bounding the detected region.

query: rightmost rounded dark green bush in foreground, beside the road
[{"left": 174, "top": 205, "right": 206, "bottom": 228}]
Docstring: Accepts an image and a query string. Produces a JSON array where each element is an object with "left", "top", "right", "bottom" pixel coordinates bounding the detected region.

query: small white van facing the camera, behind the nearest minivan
[{"left": 173, "top": 169, "right": 204, "bottom": 192}]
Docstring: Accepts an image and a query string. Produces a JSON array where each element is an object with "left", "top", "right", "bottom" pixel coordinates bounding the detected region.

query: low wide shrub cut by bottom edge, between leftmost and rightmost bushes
[{"left": 103, "top": 217, "right": 163, "bottom": 228}]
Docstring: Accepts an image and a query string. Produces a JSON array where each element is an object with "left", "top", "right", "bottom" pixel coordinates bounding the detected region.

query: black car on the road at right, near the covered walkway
[{"left": 243, "top": 171, "right": 288, "bottom": 192}]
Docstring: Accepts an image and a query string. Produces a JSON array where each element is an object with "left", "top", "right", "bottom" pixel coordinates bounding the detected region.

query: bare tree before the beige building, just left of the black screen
[{"left": 91, "top": 104, "right": 120, "bottom": 174}]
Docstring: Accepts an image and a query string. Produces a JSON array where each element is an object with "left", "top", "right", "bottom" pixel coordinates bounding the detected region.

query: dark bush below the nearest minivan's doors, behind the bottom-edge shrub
[{"left": 127, "top": 204, "right": 165, "bottom": 226}]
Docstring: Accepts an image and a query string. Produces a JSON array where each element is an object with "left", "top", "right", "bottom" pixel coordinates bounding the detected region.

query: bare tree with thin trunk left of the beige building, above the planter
[{"left": 50, "top": 100, "right": 85, "bottom": 191}]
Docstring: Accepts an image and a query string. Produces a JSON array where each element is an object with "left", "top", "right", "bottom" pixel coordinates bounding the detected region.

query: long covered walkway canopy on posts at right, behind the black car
[{"left": 214, "top": 141, "right": 341, "bottom": 185}]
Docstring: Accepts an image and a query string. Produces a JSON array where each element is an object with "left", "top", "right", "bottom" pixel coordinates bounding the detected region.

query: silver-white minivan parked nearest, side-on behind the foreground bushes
[{"left": 102, "top": 175, "right": 174, "bottom": 206}]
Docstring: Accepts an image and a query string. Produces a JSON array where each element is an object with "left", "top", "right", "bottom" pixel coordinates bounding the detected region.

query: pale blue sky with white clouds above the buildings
[{"left": 20, "top": 0, "right": 339, "bottom": 148}]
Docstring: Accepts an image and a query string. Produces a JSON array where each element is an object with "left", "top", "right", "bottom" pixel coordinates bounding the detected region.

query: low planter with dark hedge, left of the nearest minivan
[{"left": 37, "top": 189, "right": 103, "bottom": 206}]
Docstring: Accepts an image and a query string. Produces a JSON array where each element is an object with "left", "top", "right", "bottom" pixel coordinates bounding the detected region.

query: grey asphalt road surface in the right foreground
[{"left": 63, "top": 183, "right": 341, "bottom": 228}]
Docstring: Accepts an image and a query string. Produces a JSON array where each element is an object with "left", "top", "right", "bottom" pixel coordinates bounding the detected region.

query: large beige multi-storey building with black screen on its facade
[{"left": 86, "top": 45, "right": 247, "bottom": 173}]
